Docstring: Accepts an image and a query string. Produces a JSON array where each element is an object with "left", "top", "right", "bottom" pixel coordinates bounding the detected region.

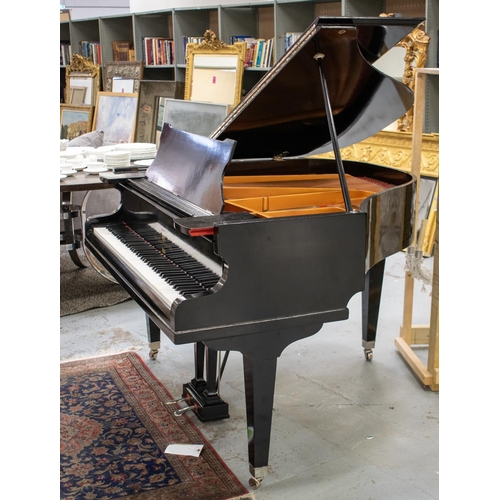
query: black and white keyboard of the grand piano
[{"left": 93, "top": 222, "right": 222, "bottom": 309}]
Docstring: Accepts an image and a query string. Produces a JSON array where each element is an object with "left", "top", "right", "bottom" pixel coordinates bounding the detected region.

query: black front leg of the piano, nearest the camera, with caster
[{"left": 205, "top": 323, "right": 323, "bottom": 489}]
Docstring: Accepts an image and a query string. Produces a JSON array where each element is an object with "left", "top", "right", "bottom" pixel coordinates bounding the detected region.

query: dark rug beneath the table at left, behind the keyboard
[{"left": 59, "top": 251, "right": 130, "bottom": 316}]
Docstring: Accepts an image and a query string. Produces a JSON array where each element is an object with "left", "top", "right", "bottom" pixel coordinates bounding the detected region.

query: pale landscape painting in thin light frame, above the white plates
[{"left": 92, "top": 92, "right": 138, "bottom": 146}]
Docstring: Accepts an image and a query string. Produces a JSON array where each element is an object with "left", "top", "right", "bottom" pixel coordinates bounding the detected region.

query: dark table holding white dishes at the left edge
[{"left": 60, "top": 171, "right": 114, "bottom": 267}]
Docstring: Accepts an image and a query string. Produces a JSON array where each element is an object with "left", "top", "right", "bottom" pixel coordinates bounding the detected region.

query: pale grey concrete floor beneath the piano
[{"left": 60, "top": 253, "right": 439, "bottom": 500}]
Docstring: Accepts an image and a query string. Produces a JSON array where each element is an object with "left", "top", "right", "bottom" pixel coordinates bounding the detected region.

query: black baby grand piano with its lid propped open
[{"left": 85, "top": 17, "right": 422, "bottom": 488}]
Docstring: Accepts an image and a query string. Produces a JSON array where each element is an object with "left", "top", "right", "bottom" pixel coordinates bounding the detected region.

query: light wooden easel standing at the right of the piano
[{"left": 395, "top": 68, "right": 439, "bottom": 391}]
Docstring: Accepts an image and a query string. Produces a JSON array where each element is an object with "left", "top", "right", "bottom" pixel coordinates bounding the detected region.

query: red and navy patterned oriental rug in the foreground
[{"left": 60, "top": 352, "right": 254, "bottom": 500}]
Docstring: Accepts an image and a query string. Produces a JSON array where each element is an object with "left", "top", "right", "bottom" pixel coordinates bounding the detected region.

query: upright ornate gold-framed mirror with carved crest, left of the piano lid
[{"left": 184, "top": 30, "right": 246, "bottom": 110}]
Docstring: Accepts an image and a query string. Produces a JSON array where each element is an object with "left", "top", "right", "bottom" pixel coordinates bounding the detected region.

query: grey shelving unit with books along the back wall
[{"left": 61, "top": 0, "right": 439, "bottom": 133}]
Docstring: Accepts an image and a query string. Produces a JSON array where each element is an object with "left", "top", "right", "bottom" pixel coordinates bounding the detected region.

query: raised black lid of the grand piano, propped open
[{"left": 211, "top": 17, "right": 424, "bottom": 159}]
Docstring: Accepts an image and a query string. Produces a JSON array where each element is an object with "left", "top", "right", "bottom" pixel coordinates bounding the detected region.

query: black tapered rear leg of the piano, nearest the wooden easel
[{"left": 362, "top": 259, "right": 385, "bottom": 361}]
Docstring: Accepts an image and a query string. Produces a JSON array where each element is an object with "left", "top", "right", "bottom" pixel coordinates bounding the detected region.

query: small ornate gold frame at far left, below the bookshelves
[{"left": 65, "top": 54, "right": 101, "bottom": 106}]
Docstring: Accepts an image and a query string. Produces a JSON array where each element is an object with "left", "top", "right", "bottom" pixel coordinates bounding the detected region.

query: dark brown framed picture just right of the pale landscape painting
[{"left": 135, "top": 80, "right": 184, "bottom": 143}]
